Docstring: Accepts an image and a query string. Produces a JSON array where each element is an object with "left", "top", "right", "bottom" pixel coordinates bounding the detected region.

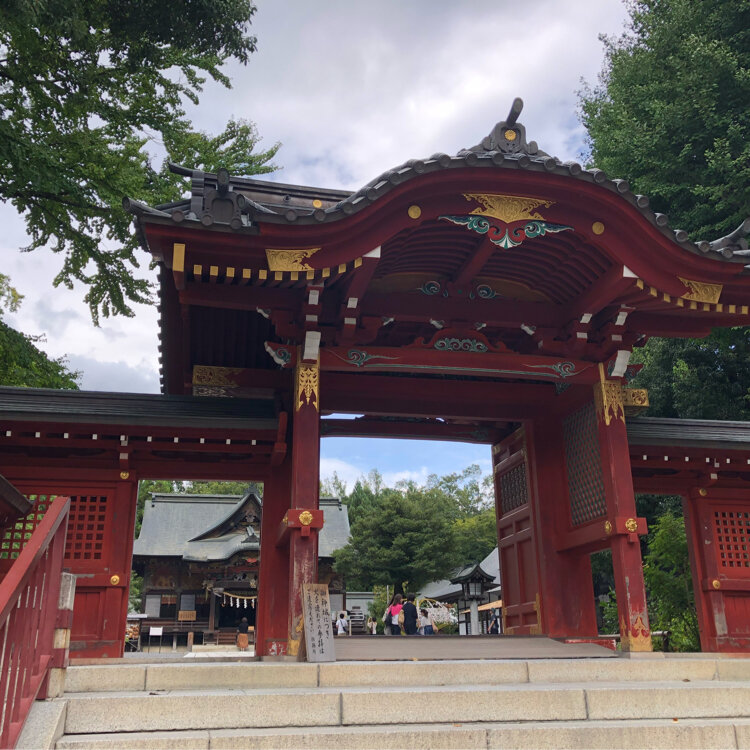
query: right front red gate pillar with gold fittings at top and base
[{"left": 594, "top": 376, "right": 652, "bottom": 651}]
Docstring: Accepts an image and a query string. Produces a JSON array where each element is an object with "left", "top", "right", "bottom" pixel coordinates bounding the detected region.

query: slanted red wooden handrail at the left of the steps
[{"left": 0, "top": 497, "right": 70, "bottom": 748}]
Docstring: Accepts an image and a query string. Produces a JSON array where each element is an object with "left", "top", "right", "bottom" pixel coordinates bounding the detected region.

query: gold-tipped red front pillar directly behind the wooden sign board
[{"left": 287, "top": 348, "right": 320, "bottom": 656}]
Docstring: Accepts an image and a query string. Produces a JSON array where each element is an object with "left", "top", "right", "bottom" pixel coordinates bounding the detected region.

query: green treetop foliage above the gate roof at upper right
[{"left": 581, "top": 0, "right": 750, "bottom": 239}]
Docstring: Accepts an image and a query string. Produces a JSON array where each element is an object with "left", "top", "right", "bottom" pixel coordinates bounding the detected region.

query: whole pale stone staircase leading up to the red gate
[{"left": 20, "top": 654, "right": 750, "bottom": 750}]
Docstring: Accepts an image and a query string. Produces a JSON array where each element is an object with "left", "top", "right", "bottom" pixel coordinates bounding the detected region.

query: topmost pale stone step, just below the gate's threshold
[{"left": 65, "top": 657, "right": 750, "bottom": 695}]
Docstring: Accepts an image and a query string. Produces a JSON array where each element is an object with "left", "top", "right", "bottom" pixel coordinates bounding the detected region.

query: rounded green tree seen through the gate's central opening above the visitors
[{"left": 334, "top": 483, "right": 457, "bottom": 593}]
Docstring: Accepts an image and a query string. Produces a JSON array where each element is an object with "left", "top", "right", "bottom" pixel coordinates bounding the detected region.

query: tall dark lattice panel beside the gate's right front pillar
[{"left": 563, "top": 402, "right": 607, "bottom": 526}]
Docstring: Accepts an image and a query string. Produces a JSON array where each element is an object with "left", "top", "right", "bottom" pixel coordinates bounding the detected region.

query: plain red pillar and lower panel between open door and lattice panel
[{"left": 526, "top": 415, "right": 597, "bottom": 638}]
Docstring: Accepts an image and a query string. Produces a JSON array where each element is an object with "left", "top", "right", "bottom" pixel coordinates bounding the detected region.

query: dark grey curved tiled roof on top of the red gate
[{"left": 124, "top": 99, "right": 750, "bottom": 270}]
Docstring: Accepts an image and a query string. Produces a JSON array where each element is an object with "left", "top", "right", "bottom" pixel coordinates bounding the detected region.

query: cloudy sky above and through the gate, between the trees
[{"left": 0, "top": 0, "right": 626, "bottom": 485}]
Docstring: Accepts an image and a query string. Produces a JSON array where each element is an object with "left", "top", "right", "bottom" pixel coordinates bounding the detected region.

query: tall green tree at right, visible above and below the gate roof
[{"left": 580, "top": 0, "right": 750, "bottom": 419}]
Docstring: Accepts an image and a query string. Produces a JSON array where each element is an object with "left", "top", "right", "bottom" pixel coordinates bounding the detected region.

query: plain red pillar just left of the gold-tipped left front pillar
[{"left": 255, "top": 456, "right": 292, "bottom": 656}]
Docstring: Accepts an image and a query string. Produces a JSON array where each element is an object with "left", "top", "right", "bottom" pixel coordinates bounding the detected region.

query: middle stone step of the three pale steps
[{"left": 62, "top": 680, "right": 750, "bottom": 734}]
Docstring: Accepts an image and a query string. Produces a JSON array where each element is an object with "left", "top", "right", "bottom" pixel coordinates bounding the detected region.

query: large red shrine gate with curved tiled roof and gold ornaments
[{"left": 0, "top": 101, "right": 750, "bottom": 656}]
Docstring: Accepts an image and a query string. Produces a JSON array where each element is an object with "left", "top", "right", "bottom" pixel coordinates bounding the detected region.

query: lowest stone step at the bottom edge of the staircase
[{"left": 57, "top": 719, "right": 750, "bottom": 750}]
